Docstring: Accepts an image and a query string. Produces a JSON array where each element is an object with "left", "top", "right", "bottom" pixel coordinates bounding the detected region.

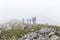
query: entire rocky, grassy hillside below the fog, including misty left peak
[{"left": 0, "top": 20, "right": 60, "bottom": 40}]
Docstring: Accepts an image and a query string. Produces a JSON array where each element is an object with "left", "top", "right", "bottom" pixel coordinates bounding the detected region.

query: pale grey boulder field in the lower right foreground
[{"left": 19, "top": 28, "right": 60, "bottom": 40}]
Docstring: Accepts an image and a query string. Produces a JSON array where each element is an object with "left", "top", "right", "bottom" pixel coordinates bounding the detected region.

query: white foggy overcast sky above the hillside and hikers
[{"left": 0, "top": 0, "right": 60, "bottom": 25}]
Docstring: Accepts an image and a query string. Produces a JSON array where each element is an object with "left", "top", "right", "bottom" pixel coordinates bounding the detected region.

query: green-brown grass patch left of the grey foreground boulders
[{"left": 0, "top": 29, "right": 29, "bottom": 39}]
